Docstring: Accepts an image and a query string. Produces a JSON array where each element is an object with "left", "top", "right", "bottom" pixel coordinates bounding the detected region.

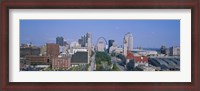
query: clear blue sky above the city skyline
[{"left": 20, "top": 20, "right": 180, "bottom": 48}]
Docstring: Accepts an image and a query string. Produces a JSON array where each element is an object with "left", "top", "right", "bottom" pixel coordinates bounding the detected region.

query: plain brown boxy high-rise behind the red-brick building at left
[{"left": 46, "top": 43, "right": 59, "bottom": 57}]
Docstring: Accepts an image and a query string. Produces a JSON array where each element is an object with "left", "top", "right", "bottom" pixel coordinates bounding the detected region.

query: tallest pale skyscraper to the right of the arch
[{"left": 123, "top": 32, "right": 133, "bottom": 56}]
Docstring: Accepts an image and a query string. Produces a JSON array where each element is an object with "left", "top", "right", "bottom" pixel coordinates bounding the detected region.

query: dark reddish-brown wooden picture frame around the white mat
[{"left": 0, "top": 0, "right": 200, "bottom": 91}]
